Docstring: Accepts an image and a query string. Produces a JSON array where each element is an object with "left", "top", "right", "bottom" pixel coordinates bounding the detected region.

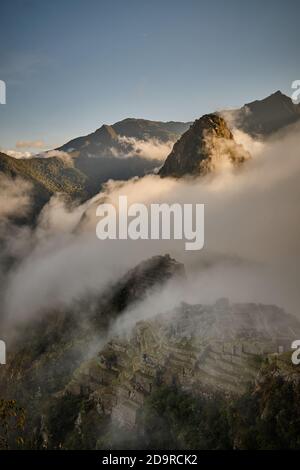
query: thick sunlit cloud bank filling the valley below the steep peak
[{"left": 4, "top": 121, "right": 300, "bottom": 326}]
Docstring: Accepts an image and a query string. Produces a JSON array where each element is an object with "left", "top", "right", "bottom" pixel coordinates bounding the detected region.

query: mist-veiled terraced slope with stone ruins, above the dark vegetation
[{"left": 87, "top": 300, "right": 300, "bottom": 428}]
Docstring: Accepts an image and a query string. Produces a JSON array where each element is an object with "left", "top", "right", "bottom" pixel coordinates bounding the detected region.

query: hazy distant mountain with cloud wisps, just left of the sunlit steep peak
[{"left": 51, "top": 118, "right": 190, "bottom": 196}]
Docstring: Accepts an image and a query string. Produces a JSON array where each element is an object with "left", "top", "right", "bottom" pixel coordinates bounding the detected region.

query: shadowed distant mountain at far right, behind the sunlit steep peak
[{"left": 221, "top": 91, "right": 300, "bottom": 137}]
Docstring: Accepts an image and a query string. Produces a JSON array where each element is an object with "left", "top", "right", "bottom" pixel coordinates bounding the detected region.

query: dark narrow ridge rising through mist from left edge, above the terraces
[{"left": 0, "top": 255, "right": 183, "bottom": 414}]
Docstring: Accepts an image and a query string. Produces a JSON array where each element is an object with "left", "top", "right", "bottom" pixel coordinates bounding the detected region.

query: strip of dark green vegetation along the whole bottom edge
[{"left": 0, "top": 365, "right": 300, "bottom": 450}]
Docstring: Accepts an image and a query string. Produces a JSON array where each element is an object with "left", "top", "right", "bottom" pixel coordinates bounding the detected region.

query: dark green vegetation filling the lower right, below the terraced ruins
[{"left": 135, "top": 373, "right": 300, "bottom": 450}]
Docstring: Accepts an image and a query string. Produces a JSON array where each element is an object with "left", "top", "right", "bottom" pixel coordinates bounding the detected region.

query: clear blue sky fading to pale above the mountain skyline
[{"left": 0, "top": 0, "right": 300, "bottom": 151}]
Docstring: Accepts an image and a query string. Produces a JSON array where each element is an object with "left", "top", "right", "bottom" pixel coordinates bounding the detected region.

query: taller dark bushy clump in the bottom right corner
[{"left": 230, "top": 371, "right": 300, "bottom": 450}]
